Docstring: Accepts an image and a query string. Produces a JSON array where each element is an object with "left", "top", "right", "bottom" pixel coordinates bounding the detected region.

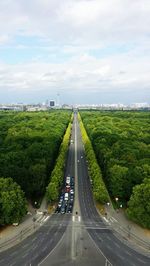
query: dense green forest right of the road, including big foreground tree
[{"left": 80, "top": 111, "right": 150, "bottom": 228}]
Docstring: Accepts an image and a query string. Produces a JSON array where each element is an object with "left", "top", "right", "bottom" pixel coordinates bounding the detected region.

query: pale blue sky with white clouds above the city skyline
[{"left": 0, "top": 0, "right": 150, "bottom": 104}]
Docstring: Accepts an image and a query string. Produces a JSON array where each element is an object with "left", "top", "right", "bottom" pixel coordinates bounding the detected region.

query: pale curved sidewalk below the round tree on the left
[{"left": 0, "top": 197, "right": 48, "bottom": 252}]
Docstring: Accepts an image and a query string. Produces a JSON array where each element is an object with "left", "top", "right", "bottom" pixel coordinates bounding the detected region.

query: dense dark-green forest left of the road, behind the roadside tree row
[{"left": 0, "top": 110, "right": 71, "bottom": 204}]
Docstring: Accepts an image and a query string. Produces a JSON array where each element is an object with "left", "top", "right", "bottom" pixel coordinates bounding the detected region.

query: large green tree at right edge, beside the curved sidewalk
[{"left": 126, "top": 178, "right": 150, "bottom": 229}]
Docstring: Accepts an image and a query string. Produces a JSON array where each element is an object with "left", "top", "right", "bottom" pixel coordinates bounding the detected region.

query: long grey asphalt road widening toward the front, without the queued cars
[{"left": 0, "top": 115, "right": 150, "bottom": 266}]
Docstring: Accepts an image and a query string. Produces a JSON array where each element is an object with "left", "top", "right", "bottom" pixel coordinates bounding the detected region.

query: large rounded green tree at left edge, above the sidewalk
[{"left": 0, "top": 177, "right": 27, "bottom": 225}]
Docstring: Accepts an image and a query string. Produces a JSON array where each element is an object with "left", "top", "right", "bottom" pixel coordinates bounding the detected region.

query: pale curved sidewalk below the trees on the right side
[{"left": 103, "top": 204, "right": 150, "bottom": 256}]
